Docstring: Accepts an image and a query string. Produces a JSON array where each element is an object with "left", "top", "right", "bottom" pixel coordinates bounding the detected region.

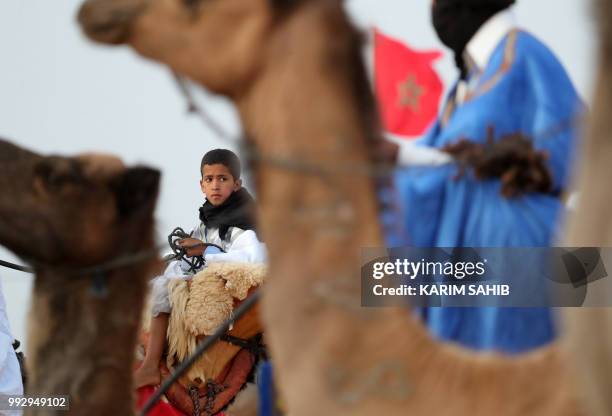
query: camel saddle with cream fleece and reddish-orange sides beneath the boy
[{"left": 160, "top": 262, "right": 267, "bottom": 416}]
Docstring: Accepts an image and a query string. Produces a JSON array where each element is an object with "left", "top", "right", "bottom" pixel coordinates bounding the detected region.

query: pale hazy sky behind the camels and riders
[{"left": 0, "top": 0, "right": 595, "bottom": 342}]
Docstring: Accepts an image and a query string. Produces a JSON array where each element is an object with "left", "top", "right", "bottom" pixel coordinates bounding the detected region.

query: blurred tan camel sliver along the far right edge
[{"left": 563, "top": 0, "right": 612, "bottom": 416}]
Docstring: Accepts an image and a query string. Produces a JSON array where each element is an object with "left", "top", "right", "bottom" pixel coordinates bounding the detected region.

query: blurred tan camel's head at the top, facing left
[{"left": 78, "top": 0, "right": 318, "bottom": 97}]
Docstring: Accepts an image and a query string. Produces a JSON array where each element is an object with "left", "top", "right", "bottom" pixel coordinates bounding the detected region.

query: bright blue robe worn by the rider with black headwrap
[{"left": 395, "top": 30, "right": 583, "bottom": 353}]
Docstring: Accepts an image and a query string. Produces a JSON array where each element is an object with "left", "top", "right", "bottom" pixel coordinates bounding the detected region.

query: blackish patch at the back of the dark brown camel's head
[{"left": 112, "top": 167, "right": 161, "bottom": 218}]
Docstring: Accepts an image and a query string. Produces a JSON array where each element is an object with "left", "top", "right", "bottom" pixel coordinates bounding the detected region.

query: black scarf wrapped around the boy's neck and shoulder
[{"left": 200, "top": 188, "right": 256, "bottom": 241}]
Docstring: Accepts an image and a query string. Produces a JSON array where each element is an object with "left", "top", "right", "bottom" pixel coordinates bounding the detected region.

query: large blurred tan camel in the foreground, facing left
[{"left": 78, "top": 0, "right": 584, "bottom": 416}]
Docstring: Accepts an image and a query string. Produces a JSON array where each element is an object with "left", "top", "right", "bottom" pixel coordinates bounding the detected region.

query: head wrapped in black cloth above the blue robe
[{"left": 432, "top": 0, "right": 515, "bottom": 73}]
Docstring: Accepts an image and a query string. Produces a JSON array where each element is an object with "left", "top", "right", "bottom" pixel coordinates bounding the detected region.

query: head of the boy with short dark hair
[{"left": 200, "top": 149, "right": 242, "bottom": 206}]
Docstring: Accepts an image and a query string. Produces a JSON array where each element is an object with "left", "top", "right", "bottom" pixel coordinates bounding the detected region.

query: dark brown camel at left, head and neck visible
[{"left": 0, "top": 140, "right": 159, "bottom": 416}]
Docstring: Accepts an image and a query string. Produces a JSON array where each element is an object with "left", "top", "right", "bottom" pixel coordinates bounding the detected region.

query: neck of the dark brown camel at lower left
[{"left": 28, "top": 265, "right": 146, "bottom": 415}]
